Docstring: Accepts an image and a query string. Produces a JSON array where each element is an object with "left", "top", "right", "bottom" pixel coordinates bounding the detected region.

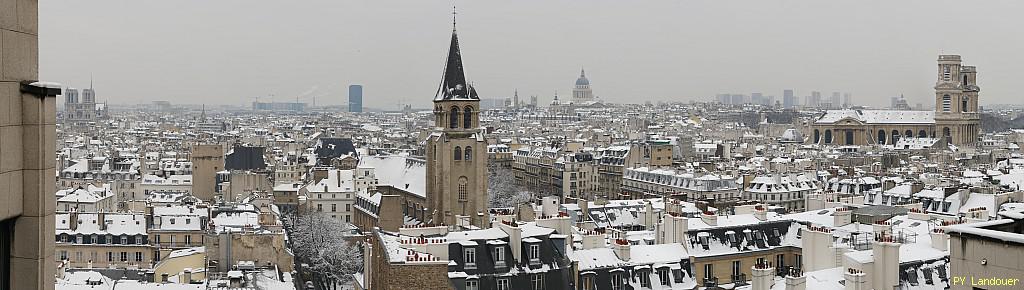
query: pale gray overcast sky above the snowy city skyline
[{"left": 39, "top": 0, "right": 1024, "bottom": 109}]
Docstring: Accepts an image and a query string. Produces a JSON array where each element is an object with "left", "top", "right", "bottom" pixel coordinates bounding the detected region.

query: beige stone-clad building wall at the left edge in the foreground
[{"left": 0, "top": 0, "right": 56, "bottom": 290}]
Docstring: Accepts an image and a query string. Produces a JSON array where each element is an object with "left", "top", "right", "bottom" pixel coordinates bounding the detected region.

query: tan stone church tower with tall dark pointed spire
[{"left": 426, "top": 25, "right": 489, "bottom": 229}]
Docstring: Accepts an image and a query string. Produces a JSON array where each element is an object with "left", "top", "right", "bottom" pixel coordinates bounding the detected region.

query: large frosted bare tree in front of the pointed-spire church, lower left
[{"left": 290, "top": 212, "right": 362, "bottom": 283}]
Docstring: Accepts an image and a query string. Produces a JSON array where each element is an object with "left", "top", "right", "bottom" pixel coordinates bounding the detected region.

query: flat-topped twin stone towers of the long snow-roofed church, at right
[{"left": 935, "top": 55, "right": 981, "bottom": 144}]
